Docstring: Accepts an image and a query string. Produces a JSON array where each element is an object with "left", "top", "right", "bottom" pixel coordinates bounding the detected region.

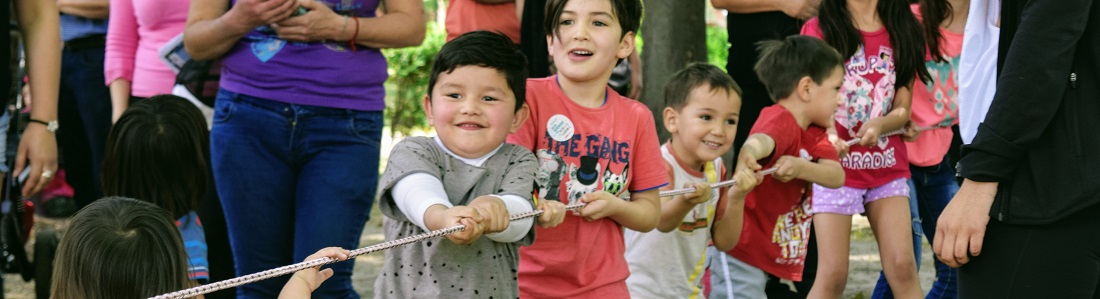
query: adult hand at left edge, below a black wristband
[{"left": 12, "top": 123, "right": 57, "bottom": 197}]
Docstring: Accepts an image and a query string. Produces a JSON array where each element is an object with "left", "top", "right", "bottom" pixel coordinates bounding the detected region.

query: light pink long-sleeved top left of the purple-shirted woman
[{"left": 103, "top": 0, "right": 190, "bottom": 97}]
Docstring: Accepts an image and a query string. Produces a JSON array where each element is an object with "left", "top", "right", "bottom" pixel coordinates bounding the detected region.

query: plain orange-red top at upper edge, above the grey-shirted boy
[{"left": 447, "top": 0, "right": 519, "bottom": 44}]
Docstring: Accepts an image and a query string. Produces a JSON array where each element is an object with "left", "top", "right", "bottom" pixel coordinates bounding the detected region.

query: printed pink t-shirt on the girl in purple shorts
[{"left": 802, "top": 18, "right": 910, "bottom": 188}]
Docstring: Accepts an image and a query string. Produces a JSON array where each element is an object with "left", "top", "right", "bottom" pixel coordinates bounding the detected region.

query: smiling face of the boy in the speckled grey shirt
[{"left": 424, "top": 66, "right": 527, "bottom": 158}]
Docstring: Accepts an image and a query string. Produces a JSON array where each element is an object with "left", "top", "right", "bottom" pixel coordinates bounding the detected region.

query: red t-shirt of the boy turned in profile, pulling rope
[{"left": 729, "top": 104, "right": 837, "bottom": 281}]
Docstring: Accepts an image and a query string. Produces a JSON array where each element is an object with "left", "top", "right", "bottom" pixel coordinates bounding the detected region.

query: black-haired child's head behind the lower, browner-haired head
[{"left": 102, "top": 95, "right": 210, "bottom": 219}]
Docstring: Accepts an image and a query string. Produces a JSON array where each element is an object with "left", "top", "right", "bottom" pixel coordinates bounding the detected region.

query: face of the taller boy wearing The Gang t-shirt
[{"left": 547, "top": 0, "right": 634, "bottom": 82}]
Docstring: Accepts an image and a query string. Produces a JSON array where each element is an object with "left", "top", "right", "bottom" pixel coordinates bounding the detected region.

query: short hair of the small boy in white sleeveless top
[{"left": 664, "top": 63, "right": 741, "bottom": 111}]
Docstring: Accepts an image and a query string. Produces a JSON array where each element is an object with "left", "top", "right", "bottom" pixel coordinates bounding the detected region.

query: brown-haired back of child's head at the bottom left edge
[{"left": 51, "top": 197, "right": 191, "bottom": 299}]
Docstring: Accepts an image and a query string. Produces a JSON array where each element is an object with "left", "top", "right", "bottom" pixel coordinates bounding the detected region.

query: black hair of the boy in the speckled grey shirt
[{"left": 428, "top": 31, "right": 527, "bottom": 111}]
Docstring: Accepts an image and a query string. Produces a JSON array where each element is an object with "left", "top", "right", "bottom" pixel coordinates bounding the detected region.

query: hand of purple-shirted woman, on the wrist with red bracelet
[{"left": 272, "top": 0, "right": 347, "bottom": 42}]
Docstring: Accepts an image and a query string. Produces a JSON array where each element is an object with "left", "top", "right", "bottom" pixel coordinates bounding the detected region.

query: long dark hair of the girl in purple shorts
[{"left": 818, "top": 0, "right": 938, "bottom": 87}]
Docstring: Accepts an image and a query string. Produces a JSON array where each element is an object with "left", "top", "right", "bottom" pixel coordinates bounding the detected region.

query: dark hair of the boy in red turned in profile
[{"left": 752, "top": 35, "right": 844, "bottom": 101}]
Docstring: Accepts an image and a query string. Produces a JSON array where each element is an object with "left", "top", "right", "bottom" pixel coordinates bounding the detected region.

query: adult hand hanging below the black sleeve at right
[{"left": 932, "top": 179, "right": 998, "bottom": 268}]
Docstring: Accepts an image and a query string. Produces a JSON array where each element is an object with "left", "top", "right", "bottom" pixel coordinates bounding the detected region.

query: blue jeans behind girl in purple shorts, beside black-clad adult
[{"left": 871, "top": 157, "right": 959, "bottom": 298}]
